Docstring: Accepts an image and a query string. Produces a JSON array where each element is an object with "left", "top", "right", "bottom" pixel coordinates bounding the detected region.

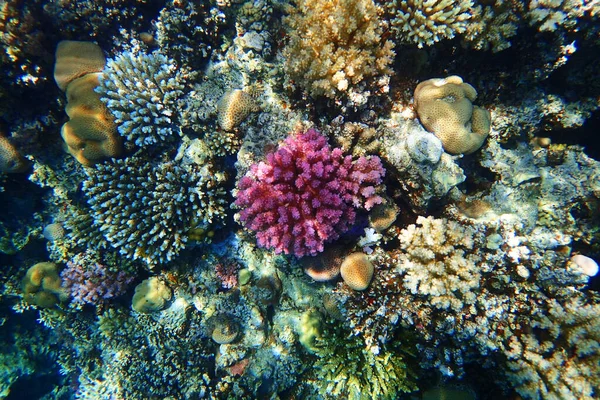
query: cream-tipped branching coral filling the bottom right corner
[{"left": 507, "top": 298, "right": 600, "bottom": 400}]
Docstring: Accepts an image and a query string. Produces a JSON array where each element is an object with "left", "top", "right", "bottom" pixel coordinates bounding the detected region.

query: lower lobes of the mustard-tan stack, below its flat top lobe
[{"left": 61, "top": 73, "right": 122, "bottom": 166}]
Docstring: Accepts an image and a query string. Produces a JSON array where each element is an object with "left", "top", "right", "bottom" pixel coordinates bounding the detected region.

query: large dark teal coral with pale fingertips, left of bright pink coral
[{"left": 83, "top": 157, "right": 224, "bottom": 265}]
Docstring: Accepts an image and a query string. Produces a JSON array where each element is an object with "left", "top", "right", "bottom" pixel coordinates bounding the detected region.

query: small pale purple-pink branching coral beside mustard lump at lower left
[{"left": 60, "top": 253, "right": 133, "bottom": 308}]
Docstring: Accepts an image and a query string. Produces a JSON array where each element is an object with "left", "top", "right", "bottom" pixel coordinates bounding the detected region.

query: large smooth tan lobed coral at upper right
[{"left": 414, "top": 75, "right": 491, "bottom": 154}]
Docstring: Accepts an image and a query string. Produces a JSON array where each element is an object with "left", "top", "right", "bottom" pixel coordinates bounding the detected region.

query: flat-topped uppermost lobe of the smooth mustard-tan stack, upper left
[{"left": 54, "top": 40, "right": 106, "bottom": 91}]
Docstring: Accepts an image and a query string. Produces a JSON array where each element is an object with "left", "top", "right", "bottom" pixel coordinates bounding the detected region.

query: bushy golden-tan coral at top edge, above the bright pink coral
[{"left": 284, "top": 0, "right": 394, "bottom": 99}]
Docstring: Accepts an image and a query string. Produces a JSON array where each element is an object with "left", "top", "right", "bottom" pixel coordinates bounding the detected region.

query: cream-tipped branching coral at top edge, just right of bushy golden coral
[{"left": 386, "top": 0, "right": 474, "bottom": 48}]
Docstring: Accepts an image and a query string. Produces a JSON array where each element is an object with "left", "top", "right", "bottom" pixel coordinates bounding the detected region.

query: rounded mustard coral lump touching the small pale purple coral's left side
[{"left": 21, "top": 262, "right": 67, "bottom": 308}]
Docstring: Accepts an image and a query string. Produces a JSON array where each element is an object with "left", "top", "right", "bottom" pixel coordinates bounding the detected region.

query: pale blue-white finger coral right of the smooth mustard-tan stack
[{"left": 96, "top": 51, "right": 184, "bottom": 147}]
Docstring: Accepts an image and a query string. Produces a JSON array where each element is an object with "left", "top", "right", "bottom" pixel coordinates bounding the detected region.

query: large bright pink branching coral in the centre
[{"left": 235, "top": 129, "right": 385, "bottom": 257}]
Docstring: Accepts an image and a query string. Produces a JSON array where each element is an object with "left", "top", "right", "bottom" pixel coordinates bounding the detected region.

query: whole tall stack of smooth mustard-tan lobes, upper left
[{"left": 54, "top": 41, "right": 122, "bottom": 166}]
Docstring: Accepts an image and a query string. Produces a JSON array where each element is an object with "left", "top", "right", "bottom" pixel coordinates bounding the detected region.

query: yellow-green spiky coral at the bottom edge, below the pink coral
[{"left": 313, "top": 326, "right": 416, "bottom": 400}]
